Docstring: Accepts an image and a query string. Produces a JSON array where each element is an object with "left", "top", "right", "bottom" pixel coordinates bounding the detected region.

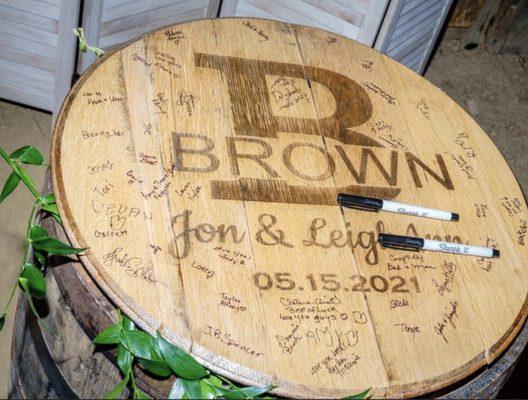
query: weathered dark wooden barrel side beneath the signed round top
[{"left": 8, "top": 179, "right": 528, "bottom": 399}]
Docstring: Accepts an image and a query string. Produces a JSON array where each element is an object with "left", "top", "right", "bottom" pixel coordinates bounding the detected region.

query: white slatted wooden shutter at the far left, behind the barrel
[{"left": 0, "top": 0, "right": 80, "bottom": 111}]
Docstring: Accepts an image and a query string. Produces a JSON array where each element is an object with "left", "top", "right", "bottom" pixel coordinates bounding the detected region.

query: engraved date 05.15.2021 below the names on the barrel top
[{"left": 253, "top": 272, "right": 421, "bottom": 293}]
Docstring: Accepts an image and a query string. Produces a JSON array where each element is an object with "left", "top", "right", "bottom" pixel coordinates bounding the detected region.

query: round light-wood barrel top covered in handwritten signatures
[{"left": 51, "top": 18, "right": 528, "bottom": 397}]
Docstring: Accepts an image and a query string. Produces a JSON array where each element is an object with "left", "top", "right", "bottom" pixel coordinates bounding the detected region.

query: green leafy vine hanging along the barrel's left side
[{"left": 0, "top": 146, "right": 85, "bottom": 330}]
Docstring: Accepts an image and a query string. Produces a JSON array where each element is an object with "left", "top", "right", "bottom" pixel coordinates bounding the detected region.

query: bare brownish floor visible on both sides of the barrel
[{"left": 0, "top": 32, "right": 528, "bottom": 398}]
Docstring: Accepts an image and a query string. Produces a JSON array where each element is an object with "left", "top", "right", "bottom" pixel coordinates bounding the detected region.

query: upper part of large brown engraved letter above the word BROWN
[{"left": 194, "top": 53, "right": 381, "bottom": 146}]
